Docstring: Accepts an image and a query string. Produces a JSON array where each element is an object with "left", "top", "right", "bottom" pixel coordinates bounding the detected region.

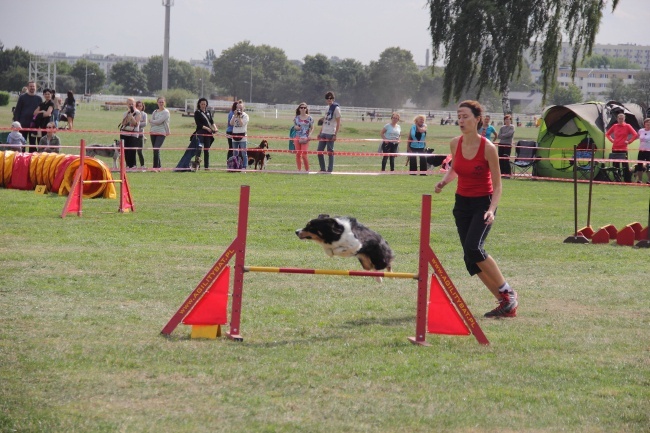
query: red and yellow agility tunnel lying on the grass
[{"left": 0, "top": 150, "right": 117, "bottom": 198}]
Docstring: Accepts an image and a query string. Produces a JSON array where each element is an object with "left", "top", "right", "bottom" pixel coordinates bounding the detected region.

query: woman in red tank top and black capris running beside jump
[{"left": 435, "top": 101, "right": 519, "bottom": 318}]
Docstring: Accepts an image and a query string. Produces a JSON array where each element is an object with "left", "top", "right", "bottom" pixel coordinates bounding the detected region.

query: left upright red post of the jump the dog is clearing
[{"left": 226, "top": 185, "right": 250, "bottom": 341}]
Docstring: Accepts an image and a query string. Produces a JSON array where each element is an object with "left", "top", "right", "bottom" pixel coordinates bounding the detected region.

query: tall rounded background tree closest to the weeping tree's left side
[{"left": 368, "top": 47, "right": 420, "bottom": 109}]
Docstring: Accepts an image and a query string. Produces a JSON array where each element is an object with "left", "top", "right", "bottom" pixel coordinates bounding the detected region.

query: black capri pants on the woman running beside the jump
[{"left": 453, "top": 194, "right": 496, "bottom": 275}]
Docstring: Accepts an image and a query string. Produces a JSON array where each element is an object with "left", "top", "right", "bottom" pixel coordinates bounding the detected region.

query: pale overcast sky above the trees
[{"left": 0, "top": 0, "right": 650, "bottom": 65}]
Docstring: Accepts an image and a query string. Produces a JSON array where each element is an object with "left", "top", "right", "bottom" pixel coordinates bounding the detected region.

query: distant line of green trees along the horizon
[{"left": 0, "top": 37, "right": 650, "bottom": 111}]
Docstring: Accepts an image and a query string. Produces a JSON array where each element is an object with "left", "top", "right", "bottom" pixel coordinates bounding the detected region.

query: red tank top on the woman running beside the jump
[{"left": 452, "top": 137, "right": 493, "bottom": 197}]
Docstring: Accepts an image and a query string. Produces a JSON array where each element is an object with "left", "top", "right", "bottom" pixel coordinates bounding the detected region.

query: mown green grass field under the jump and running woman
[{"left": 0, "top": 102, "right": 650, "bottom": 433}]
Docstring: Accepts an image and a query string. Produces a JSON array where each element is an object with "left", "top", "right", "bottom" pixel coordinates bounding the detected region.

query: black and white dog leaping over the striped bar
[{"left": 296, "top": 214, "right": 395, "bottom": 281}]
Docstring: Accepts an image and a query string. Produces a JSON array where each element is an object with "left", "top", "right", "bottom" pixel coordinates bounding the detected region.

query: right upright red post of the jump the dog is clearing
[{"left": 409, "top": 194, "right": 431, "bottom": 346}]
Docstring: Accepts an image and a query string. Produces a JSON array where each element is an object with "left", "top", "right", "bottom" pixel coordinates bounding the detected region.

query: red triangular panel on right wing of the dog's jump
[{"left": 427, "top": 274, "right": 470, "bottom": 335}]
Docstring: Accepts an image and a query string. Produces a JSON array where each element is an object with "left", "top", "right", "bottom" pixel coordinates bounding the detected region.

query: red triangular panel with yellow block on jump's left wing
[{"left": 183, "top": 266, "right": 230, "bottom": 339}]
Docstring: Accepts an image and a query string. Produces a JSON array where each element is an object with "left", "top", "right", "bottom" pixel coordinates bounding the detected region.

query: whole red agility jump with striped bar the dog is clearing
[{"left": 161, "top": 185, "right": 490, "bottom": 346}]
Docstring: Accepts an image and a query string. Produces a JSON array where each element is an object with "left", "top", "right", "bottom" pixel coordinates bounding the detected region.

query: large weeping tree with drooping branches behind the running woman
[{"left": 428, "top": 0, "right": 619, "bottom": 111}]
